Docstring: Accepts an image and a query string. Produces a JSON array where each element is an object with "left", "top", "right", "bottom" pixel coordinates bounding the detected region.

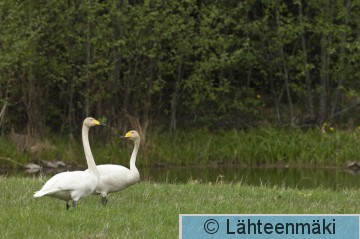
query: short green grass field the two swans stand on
[{"left": 0, "top": 177, "right": 360, "bottom": 238}]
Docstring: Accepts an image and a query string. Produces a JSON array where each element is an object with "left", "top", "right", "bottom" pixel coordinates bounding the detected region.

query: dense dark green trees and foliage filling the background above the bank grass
[{"left": 0, "top": 0, "right": 360, "bottom": 135}]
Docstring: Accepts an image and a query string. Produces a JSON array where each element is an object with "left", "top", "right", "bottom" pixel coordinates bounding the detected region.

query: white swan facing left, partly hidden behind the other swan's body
[{"left": 90, "top": 130, "right": 140, "bottom": 205}]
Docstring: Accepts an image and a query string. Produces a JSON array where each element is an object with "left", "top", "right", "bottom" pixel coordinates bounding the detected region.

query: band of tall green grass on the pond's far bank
[{"left": 0, "top": 128, "right": 360, "bottom": 167}]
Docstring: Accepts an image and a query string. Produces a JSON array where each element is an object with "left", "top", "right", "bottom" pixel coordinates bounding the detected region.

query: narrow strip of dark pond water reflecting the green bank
[{"left": 0, "top": 167, "right": 360, "bottom": 189}]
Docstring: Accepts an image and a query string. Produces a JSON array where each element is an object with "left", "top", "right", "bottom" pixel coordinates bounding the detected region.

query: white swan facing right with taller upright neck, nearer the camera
[{"left": 34, "top": 117, "right": 101, "bottom": 209}]
